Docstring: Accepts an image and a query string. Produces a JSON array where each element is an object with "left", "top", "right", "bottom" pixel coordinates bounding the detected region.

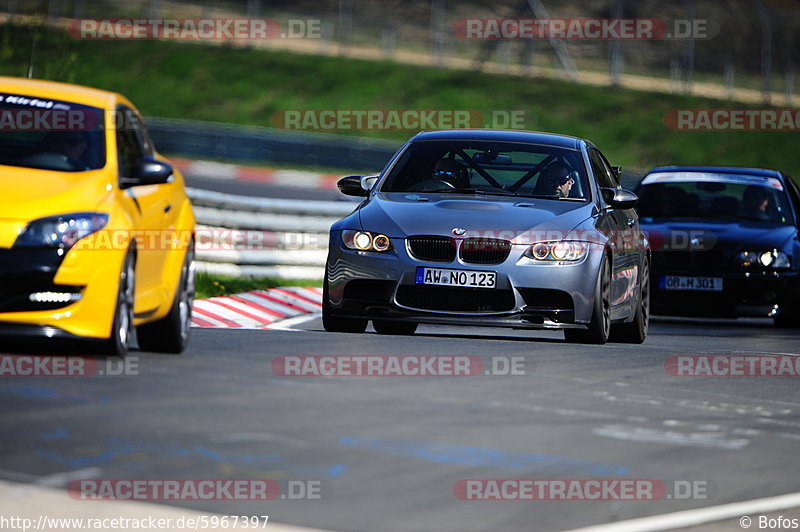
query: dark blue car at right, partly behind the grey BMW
[{"left": 635, "top": 166, "right": 800, "bottom": 327}]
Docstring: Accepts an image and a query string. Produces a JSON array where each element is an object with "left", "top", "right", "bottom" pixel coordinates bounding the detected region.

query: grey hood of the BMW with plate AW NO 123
[{"left": 359, "top": 193, "right": 593, "bottom": 240}]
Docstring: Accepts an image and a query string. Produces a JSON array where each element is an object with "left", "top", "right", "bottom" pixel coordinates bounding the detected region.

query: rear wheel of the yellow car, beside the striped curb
[{"left": 136, "top": 242, "right": 196, "bottom": 353}]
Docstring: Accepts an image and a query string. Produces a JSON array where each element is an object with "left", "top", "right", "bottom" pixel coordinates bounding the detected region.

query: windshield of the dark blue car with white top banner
[{"left": 636, "top": 172, "right": 794, "bottom": 225}]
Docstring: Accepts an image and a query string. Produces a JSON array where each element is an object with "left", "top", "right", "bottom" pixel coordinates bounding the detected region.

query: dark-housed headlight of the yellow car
[{"left": 14, "top": 212, "right": 108, "bottom": 250}]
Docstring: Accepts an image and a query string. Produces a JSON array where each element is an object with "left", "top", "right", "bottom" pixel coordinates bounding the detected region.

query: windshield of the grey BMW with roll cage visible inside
[{"left": 381, "top": 140, "right": 588, "bottom": 201}]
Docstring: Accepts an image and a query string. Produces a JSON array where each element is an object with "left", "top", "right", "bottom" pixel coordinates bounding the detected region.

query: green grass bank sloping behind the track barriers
[{"left": 0, "top": 25, "right": 800, "bottom": 176}]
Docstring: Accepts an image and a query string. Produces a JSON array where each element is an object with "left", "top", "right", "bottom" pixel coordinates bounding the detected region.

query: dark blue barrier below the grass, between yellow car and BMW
[{"left": 146, "top": 117, "right": 400, "bottom": 171}]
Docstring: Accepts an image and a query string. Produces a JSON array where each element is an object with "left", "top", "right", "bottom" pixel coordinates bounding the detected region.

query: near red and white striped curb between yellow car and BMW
[{"left": 192, "top": 286, "right": 322, "bottom": 329}]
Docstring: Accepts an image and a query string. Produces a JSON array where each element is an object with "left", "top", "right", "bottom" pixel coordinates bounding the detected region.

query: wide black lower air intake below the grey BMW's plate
[{"left": 397, "top": 285, "right": 515, "bottom": 312}]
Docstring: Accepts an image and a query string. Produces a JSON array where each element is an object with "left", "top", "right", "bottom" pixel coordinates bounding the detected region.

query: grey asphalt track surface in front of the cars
[{"left": 0, "top": 319, "right": 800, "bottom": 532}]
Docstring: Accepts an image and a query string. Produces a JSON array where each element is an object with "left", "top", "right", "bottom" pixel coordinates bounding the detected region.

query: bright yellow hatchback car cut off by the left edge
[{"left": 0, "top": 77, "right": 195, "bottom": 356}]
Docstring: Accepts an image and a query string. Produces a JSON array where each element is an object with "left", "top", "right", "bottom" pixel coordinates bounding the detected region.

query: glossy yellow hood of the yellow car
[{"left": 0, "top": 165, "right": 111, "bottom": 248}]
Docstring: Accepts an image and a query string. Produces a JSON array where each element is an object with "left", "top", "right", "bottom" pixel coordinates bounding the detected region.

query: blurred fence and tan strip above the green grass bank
[{"left": 0, "top": 0, "right": 800, "bottom": 105}]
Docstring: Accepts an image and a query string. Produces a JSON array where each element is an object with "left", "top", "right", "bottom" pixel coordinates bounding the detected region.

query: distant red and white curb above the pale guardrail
[{"left": 170, "top": 158, "right": 342, "bottom": 188}]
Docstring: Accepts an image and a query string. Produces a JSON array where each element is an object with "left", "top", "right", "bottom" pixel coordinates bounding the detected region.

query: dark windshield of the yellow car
[{"left": 0, "top": 94, "right": 105, "bottom": 172}]
